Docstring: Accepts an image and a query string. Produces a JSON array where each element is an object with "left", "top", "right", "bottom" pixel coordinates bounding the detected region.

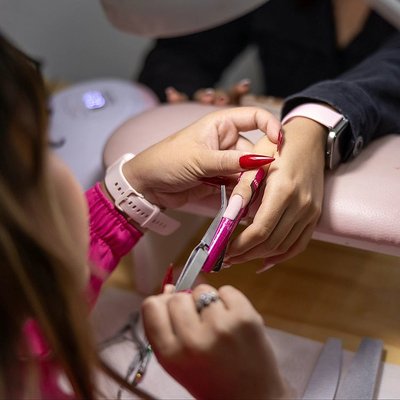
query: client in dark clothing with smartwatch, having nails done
[{"left": 138, "top": 0, "right": 400, "bottom": 269}]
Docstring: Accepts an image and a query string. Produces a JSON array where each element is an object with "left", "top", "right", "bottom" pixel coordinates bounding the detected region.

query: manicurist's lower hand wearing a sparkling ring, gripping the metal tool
[{"left": 142, "top": 284, "right": 288, "bottom": 399}]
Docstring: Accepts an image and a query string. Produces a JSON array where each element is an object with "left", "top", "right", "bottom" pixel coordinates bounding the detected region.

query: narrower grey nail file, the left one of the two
[{"left": 302, "top": 338, "right": 342, "bottom": 400}]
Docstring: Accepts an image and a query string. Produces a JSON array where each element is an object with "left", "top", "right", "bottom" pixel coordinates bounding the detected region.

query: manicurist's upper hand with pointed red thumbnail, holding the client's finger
[{"left": 124, "top": 107, "right": 280, "bottom": 207}]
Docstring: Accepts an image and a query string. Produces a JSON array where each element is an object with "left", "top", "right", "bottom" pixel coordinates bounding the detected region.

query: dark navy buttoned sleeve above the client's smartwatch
[{"left": 282, "top": 33, "right": 400, "bottom": 161}]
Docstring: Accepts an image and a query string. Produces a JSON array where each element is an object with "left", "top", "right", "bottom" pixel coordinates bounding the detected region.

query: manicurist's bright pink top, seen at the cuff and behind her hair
[{"left": 23, "top": 184, "right": 142, "bottom": 400}]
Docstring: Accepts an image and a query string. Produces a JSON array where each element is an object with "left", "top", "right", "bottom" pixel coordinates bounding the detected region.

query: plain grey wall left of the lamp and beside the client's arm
[{"left": 0, "top": 0, "right": 262, "bottom": 93}]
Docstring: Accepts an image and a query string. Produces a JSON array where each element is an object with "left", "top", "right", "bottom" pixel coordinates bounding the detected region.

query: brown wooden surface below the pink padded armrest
[{"left": 110, "top": 225, "right": 400, "bottom": 365}]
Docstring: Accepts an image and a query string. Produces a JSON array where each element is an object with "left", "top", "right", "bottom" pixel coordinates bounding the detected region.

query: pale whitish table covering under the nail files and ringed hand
[{"left": 92, "top": 288, "right": 400, "bottom": 400}]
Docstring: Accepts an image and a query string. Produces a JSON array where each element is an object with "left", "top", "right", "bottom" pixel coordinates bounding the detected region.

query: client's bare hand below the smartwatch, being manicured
[{"left": 225, "top": 117, "right": 327, "bottom": 267}]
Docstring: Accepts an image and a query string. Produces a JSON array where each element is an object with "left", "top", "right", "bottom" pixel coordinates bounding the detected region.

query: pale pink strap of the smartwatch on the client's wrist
[{"left": 282, "top": 103, "right": 343, "bottom": 129}]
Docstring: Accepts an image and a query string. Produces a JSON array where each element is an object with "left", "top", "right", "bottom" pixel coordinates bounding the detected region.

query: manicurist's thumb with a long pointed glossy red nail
[{"left": 199, "top": 150, "right": 275, "bottom": 177}]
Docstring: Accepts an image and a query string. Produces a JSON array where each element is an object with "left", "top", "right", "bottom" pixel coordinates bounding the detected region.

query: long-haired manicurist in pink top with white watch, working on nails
[{"left": 0, "top": 35, "right": 290, "bottom": 400}]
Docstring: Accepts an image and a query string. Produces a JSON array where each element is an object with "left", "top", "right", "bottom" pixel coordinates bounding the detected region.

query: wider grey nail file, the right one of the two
[{"left": 335, "top": 338, "right": 383, "bottom": 400}]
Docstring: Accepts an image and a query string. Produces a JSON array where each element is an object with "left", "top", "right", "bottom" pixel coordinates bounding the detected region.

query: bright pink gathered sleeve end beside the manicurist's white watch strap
[{"left": 86, "top": 183, "right": 143, "bottom": 304}]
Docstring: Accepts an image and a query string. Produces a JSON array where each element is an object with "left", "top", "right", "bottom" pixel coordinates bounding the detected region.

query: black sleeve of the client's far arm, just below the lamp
[{"left": 138, "top": 16, "right": 249, "bottom": 101}]
